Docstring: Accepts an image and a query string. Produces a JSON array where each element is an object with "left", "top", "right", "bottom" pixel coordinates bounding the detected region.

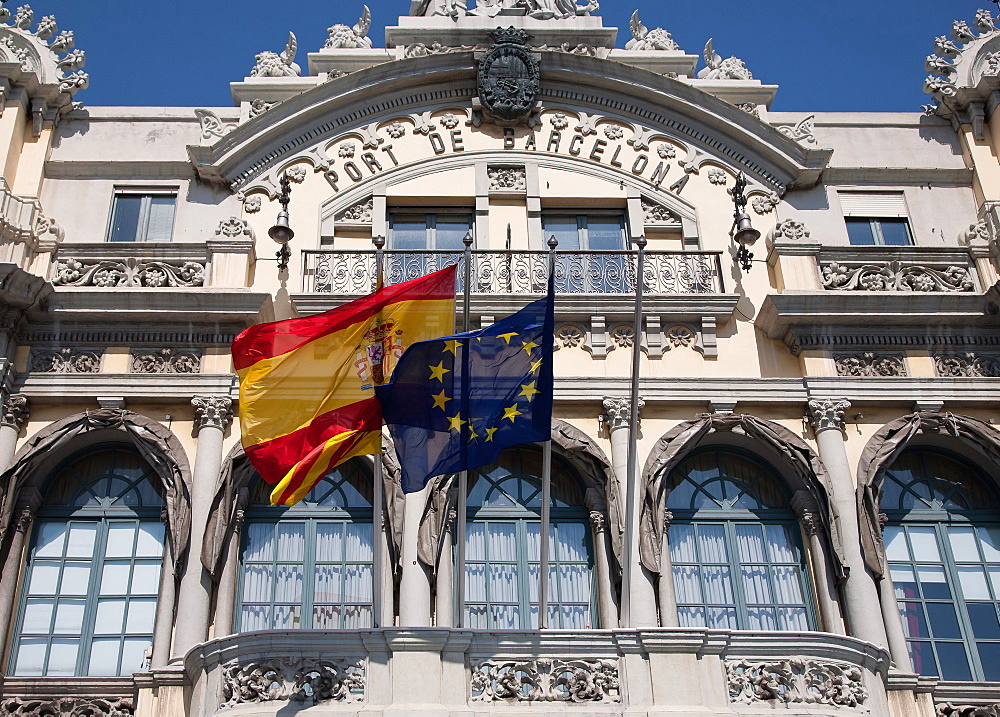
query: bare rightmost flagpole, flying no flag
[{"left": 621, "top": 236, "right": 646, "bottom": 627}]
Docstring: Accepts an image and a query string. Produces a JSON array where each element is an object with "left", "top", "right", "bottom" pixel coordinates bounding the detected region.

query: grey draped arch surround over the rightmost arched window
[{"left": 857, "top": 412, "right": 1000, "bottom": 577}]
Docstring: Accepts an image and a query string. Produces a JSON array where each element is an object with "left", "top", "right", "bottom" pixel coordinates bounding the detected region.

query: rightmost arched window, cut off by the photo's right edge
[{"left": 880, "top": 450, "right": 1000, "bottom": 682}]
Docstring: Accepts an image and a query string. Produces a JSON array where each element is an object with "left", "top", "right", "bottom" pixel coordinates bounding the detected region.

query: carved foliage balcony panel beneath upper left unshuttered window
[{"left": 52, "top": 258, "right": 205, "bottom": 288}]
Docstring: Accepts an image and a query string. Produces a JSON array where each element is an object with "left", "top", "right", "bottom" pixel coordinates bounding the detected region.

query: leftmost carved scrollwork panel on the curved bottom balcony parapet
[{"left": 222, "top": 657, "right": 365, "bottom": 707}]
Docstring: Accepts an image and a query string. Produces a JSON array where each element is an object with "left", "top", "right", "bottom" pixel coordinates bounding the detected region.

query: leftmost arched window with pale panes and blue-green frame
[{"left": 9, "top": 447, "right": 164, "bottom": 677}]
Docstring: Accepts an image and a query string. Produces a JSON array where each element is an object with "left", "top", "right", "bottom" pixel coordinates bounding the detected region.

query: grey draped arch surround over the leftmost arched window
[{"left": 0, "top": 409, "right": 191, "bottom": 566}]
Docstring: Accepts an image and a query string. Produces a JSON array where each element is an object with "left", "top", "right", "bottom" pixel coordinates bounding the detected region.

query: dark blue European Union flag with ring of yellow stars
[{"left": 375, "top": 286, "right": 555, "bottom": 493}]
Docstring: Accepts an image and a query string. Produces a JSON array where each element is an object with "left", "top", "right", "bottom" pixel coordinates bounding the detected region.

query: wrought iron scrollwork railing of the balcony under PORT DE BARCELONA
[{"left": 302, "top": 250, "right": 723, "bottom": 295}]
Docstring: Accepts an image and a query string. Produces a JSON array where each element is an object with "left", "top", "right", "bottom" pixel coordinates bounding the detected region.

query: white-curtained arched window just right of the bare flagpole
[{"left": 667, "top": 450, "right": 816, "bottom": 630}]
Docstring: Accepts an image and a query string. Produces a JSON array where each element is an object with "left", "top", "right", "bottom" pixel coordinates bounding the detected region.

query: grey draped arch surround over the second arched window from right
[{"left": 639, "top": 414, "right": 844, "bottom": 576}]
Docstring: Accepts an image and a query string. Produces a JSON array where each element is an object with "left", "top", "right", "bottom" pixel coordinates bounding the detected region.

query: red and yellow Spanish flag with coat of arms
[{"left": 233, "top": 266, "right": 456, "bottom": 505}]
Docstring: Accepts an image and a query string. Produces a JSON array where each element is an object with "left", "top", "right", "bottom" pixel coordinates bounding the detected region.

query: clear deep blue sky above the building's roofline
[{"left": 33, "top": 0, "right": 984, "bottom": 112}]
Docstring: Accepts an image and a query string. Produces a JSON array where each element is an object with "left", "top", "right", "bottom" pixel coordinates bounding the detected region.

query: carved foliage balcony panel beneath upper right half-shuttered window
[{"left": 822, "top": 262, "right": 976, "bottom": 293}]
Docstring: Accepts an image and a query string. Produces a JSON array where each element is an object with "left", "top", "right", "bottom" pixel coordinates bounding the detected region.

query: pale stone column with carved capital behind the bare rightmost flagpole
[{"left": 603, "top": 398, "right": 658, "bottom": 627}]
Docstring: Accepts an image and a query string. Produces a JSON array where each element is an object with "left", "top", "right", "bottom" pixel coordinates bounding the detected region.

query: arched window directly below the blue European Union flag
[{"left": 464, "top": 447, "right": 595, "bottom": 630}]
